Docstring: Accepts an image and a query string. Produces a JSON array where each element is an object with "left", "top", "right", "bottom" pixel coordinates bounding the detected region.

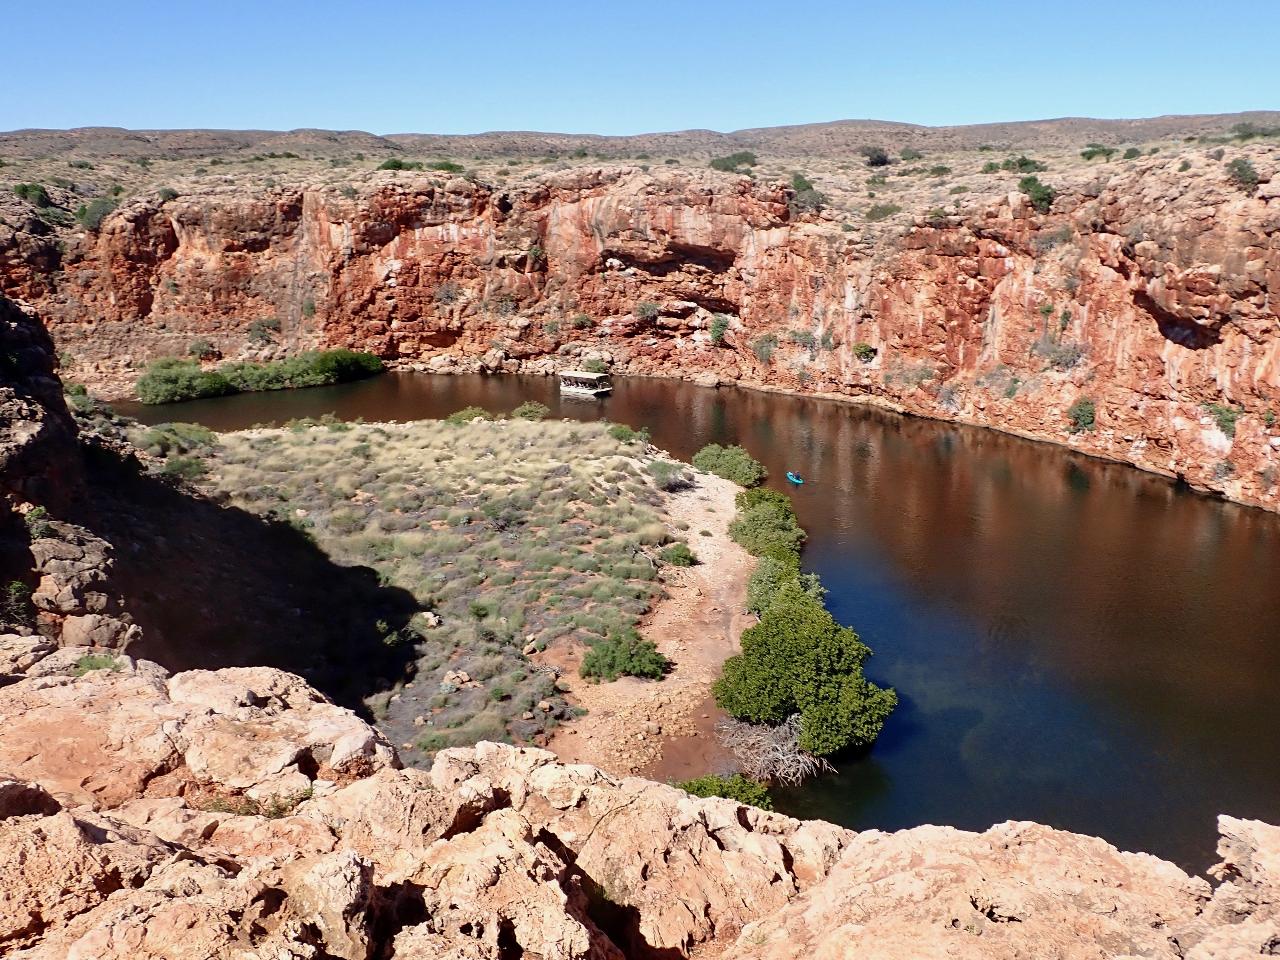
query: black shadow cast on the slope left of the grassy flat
[{"left": 76, "top": 444, "right": 421, "bottom": 713}]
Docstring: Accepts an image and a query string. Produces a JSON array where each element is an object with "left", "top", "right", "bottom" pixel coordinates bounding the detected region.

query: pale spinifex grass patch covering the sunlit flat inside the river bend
[{"left": 198, "top": 411, "right": 687, "bottom": 759}]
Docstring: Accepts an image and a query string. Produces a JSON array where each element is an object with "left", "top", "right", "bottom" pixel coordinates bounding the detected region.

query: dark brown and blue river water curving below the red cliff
[{"left": 122, "top": 375, "right": 1280, "bottom": 869}]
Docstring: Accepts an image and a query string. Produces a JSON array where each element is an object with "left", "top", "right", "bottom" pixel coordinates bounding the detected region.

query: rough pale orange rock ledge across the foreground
[{"left": 0, "top": 658, "right": 1280, "bottom": 960}]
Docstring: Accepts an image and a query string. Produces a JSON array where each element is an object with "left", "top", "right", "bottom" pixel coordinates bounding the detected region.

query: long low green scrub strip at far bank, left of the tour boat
[{"left": 137, "top": 349, "right": 383, "bottom": 403}]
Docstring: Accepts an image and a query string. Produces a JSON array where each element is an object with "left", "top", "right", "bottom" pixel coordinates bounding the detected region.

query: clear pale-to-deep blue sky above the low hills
[{"left": 10, "top": 0, "right": 1280, "bottom": 133}]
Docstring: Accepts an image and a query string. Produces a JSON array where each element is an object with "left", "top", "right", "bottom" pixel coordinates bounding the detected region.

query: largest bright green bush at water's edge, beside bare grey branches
[{"left": 714, "top": 584, "right": 897, "bottom": 756}]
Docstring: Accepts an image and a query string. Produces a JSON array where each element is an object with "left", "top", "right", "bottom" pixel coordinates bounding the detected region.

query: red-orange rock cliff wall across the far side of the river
[{"left": 4, "top": 146, "right": 1280, "bottom": 508}]
